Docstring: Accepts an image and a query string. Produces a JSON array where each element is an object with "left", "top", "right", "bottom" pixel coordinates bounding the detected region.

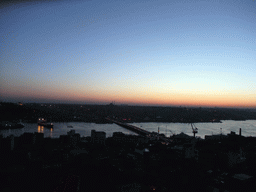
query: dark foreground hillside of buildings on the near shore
[{"left": 0, "top": 127, "right": 256, "bottom": 192}]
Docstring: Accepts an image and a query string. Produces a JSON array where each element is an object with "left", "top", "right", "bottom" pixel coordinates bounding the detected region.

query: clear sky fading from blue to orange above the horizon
[{"left": 0, "top": 0, "right": 256, "bottom": 107}]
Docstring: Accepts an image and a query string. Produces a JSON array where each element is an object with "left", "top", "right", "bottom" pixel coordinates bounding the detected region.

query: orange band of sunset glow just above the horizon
[{"left": 4, "top": 85, "right": 256, "bottom": 108}]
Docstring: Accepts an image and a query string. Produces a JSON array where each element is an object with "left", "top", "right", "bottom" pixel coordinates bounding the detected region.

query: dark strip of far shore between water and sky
[{"left": 0, "top": 102, "right": 256, "bottom": 123}]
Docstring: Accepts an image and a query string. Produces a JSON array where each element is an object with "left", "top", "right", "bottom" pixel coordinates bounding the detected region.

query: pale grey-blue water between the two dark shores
[{"left": 0, "top": 120, "right": 256, "bottom": 138}]
